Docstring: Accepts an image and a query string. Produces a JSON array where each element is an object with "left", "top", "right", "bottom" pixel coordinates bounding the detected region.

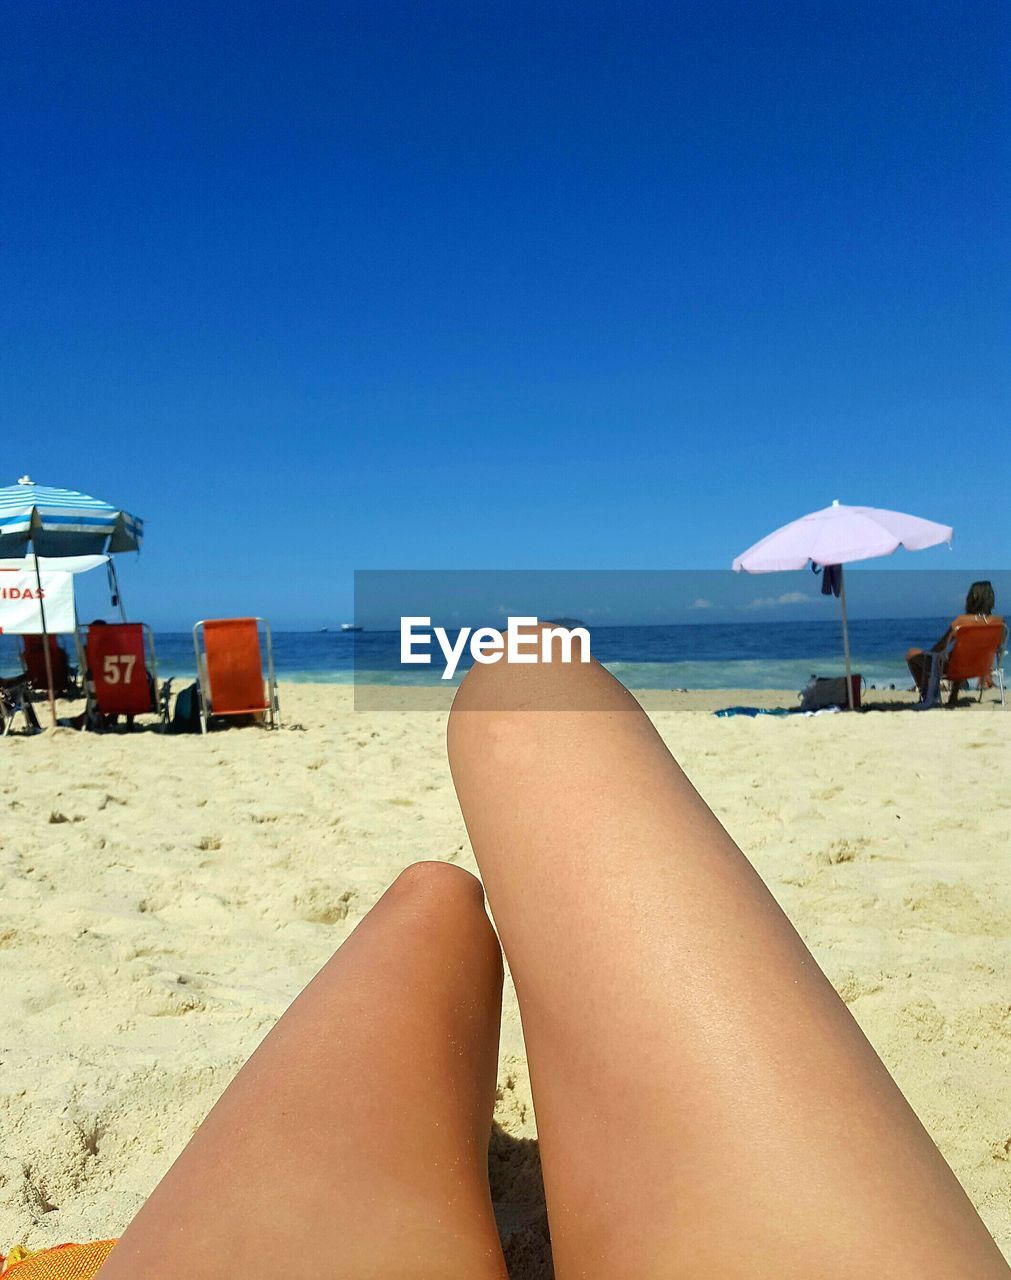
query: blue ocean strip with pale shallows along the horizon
[{"left": 0, "top": 617, "right": 950, "bottom": 690}]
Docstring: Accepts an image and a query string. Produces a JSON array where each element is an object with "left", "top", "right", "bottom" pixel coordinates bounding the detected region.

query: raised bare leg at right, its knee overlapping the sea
[{"left": 449, "top": 664, "right": 1008, "bottom": 1280}]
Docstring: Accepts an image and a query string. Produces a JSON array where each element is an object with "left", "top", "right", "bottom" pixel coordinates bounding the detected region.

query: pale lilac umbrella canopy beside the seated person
[{"left": 733, "top": 502, "right": 952, "bottom": 573}]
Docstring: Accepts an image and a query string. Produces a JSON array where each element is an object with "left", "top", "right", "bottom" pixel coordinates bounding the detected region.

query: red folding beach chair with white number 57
[{"left": 78, "top": 622, "right": 165, "bottom": 728}]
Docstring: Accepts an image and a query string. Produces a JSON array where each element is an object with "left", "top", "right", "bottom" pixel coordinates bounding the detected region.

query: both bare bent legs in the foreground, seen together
[{"left": 15, "top": 650, "right": 1008, "bottom": 1280}]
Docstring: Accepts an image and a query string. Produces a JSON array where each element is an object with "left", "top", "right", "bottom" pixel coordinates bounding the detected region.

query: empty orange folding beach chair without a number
[{"left": 193, "top": 618, "right": 280, "bottom": 733}]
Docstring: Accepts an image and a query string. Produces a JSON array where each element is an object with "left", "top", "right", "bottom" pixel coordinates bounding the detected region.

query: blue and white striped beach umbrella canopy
[{"left": 0, "top": 476, "right": 143, "bottom": 558}]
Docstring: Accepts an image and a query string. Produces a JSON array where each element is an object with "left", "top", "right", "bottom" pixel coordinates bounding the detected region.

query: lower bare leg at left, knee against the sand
[{"left": 101, "top": 863, "right": 506, "bottom": 1280}]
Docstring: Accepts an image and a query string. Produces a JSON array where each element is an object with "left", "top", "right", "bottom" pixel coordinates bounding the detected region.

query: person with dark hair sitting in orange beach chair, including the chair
[{"left": 906, "top": 581, "right": 1007, "bottom": 708}]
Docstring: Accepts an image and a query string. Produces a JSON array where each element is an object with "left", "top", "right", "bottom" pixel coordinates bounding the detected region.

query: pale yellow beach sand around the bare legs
[{"left": 0, "top": 685, "right": 1011, "bottom": 1280}]
